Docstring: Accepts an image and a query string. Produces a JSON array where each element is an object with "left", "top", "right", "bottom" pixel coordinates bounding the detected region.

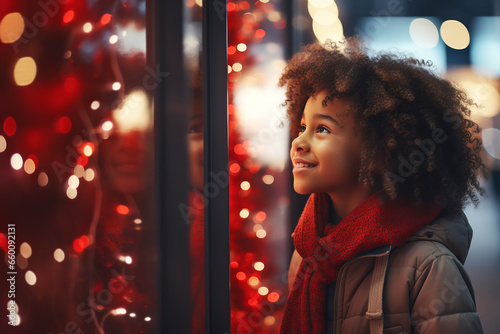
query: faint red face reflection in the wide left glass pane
[{"left": 100, "top": 131, "right": 147, "bottom": 194}]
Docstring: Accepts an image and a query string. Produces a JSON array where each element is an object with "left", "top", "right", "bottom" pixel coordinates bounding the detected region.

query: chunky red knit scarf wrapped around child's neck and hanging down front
[{"left": 280, "top": 193, "right": 441, "bottom": 334}]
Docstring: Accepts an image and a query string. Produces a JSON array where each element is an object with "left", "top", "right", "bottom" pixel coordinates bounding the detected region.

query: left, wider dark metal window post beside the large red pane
[{"left": 146, "top": 0, "right": 190, "bottom": 334}]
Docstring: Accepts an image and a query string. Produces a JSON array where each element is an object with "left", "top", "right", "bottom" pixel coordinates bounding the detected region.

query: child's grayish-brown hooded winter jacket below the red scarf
[{"left": 289, "top": 207, "right": 483, "bottom": 334}]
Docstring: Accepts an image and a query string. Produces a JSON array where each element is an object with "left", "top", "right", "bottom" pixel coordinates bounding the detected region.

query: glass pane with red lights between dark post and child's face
[{"left": 227, "top": 1, "right": 291, "bottom": 333}]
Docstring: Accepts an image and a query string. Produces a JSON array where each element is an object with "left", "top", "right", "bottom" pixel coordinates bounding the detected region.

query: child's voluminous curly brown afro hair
[{"left": 279, "top": 37, "right": 487, "bottom": 210}]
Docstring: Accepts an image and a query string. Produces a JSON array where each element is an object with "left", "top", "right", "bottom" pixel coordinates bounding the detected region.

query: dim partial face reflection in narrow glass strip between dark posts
[{"left": 188, "top": 112, "right": 203, "bottom": 190}]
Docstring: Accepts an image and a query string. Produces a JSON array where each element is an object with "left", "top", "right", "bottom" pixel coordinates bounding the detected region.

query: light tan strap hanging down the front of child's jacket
[{"left": 366, "top": 253, "right": 389, "bottom": 334}]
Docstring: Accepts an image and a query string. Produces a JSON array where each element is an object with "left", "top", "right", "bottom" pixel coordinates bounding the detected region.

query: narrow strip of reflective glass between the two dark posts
[{"left": 184, "top": 0, "right": 205, "bottom": 334}]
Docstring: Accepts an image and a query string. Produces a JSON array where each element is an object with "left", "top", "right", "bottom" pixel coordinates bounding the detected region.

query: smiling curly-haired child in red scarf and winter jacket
[{"left": 279, "top": 38, "right": 486, "bottom": 334}]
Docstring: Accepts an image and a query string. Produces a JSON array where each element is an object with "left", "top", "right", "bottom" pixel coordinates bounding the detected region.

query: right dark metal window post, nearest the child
[{"left": 202, "top": 0, "right": 231, "bottom": 333}]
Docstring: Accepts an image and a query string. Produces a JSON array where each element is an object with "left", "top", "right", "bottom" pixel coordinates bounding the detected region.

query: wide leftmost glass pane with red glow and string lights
[{"left": 0, "top": 0, "right": 158, "bottom": 333}]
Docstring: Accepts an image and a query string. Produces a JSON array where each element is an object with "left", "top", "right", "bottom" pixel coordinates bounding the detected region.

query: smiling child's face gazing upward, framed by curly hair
[{"left": 290, "top": 91, "right": 361, "bottom": 194}]
